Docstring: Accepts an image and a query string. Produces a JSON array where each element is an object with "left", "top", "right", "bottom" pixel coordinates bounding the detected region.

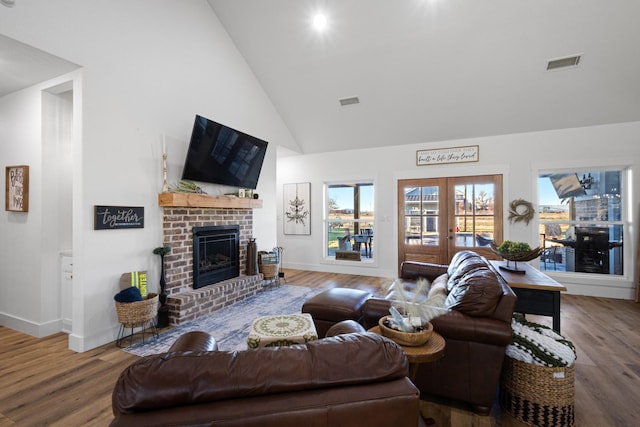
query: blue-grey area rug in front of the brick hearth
[{"left": 123, "top": 285, "right": 323, "bottom": 356}]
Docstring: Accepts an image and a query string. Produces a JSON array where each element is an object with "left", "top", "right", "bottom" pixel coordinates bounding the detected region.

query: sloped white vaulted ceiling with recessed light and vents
[{"left": 208, "top": 0, "right": 640, "bottom": 153}]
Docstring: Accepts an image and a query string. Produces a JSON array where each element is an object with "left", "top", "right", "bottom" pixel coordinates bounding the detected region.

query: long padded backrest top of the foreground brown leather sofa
[{"left": 112, "top": 332, "right": 409, "bottom": 413}]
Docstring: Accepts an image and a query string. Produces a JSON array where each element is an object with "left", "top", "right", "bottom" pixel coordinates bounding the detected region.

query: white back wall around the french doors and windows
[{"left": 277, "top": 122, "right": 640, "bottom": 299}]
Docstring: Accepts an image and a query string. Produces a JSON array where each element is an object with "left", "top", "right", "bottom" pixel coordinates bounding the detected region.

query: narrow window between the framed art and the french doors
[{"left": 325, "top": 182, "right": 375, "bottom": 261}]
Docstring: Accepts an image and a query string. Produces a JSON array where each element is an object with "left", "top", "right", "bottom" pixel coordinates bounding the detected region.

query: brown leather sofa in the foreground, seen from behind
[{"left": 111, "top": 321, "right": 424, "bottom": 427}]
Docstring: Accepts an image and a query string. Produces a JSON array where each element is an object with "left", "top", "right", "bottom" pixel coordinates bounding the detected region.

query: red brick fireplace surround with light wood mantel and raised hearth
[{"left": 158, "top": 193, "right": 263, "bottom": 325}]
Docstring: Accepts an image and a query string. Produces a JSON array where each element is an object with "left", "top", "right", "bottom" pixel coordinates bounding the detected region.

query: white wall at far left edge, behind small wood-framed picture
[{"left": 0, "top": 83, "right": 44, "bottom": 335}]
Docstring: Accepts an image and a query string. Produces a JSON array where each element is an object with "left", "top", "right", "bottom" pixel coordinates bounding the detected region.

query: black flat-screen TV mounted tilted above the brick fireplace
[{"left": 182, "top": 115, "right": 268, "bottom": 189}]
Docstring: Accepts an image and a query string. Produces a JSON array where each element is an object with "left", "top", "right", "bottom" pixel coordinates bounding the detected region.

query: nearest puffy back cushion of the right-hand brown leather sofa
[{"left": 445, "top": 268, "right": 502, "bottom": 316}]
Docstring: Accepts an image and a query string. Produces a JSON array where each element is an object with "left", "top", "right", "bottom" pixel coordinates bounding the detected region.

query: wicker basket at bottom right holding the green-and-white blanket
[{"left": 500, "top": 357, "right": 575, "bottom": 427}]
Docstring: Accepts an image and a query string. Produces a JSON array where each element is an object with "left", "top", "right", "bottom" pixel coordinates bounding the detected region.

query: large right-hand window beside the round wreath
[{"left": 538, "top": 170, "right": 626, "bottom": 275}]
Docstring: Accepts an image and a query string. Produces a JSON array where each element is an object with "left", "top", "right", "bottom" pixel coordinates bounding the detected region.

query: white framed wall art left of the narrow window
[{"left": 283, "top": 182, "right": 311, "bottom": 235}]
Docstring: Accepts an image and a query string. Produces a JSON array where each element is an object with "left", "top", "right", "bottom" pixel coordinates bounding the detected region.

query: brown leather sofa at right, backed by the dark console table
[{"left": 303, "top": 251, "right": 516, "bottom": 415}]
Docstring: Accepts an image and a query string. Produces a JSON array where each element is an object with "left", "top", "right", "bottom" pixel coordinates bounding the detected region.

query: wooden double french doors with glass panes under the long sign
[{"left": 398, "top": 175, "right": 502, "bottom": 267}]
